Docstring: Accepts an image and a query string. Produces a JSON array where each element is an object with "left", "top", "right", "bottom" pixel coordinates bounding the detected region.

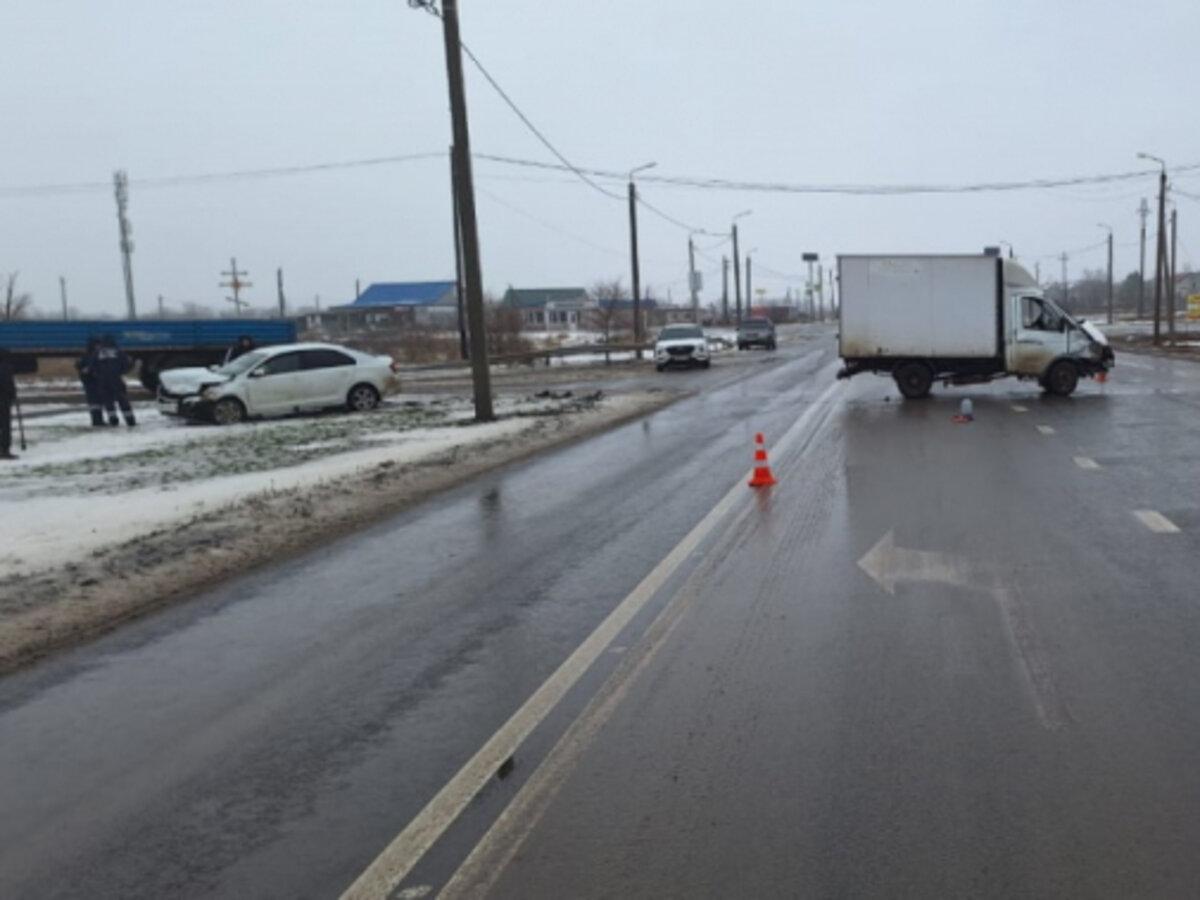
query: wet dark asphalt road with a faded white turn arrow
[{"left": 0, "top": 337, "right": 1200, "bottom": 898}]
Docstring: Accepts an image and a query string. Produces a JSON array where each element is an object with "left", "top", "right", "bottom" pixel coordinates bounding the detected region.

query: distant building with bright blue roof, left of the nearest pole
[{"left": 300, "top": 281, "right": 458, "bottom": 334}]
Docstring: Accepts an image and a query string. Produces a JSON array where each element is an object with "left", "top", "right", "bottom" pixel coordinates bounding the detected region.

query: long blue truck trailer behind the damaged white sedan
[{"left": 0, "top": 319, "right": 296, "bottom": 391}]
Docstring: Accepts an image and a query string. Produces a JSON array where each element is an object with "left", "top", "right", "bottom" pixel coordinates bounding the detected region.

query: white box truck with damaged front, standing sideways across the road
[{"left": 838, "top": 253, "right": 1114, "bottom": 398}]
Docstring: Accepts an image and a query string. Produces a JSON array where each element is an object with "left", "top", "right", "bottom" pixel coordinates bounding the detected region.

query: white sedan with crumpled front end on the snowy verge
[{"left": 158, "top": 343, "right": 397, "bottom": 425}]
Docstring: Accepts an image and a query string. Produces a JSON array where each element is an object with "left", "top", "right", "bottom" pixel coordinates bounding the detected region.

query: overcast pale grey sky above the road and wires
[{"left": 0, "top": 0, "right": 1200, "bottom": 314}]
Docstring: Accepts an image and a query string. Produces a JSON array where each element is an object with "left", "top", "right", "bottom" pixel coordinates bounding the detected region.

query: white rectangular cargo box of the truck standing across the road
[{"left": 838, "top": 256, "right": 1004, "bottom": 360}]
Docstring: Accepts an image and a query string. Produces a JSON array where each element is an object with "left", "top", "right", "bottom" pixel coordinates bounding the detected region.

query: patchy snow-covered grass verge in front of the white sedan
[{"left": 0, "top": 397, "right": 604, "bottom": 577}]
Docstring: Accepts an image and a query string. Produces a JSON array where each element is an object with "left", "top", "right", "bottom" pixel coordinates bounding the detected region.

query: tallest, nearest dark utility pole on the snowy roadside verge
[{"left": 442, "top": 0, "right": 496, "bottom": 422}]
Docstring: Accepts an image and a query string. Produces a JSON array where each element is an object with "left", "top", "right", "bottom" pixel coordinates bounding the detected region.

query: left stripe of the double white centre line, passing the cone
[{"left": 342, "top": 382, "right": 840, "bottom": 900}]
